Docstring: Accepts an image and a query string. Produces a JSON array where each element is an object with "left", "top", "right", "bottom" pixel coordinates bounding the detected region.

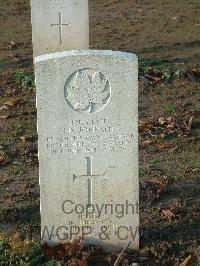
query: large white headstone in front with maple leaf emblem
[{"left": 35, "top": 51, "right": 139, "bottom": 250}]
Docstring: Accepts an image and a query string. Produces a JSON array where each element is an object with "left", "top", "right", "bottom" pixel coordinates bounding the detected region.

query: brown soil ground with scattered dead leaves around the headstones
[{"left": 0, "top": 0, "right": 200, "bottom": 266}]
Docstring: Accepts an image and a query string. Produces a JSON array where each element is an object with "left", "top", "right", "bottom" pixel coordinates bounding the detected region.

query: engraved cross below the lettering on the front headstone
[{"left": 73, "top": 157, "right": 106, "bottom": 205}]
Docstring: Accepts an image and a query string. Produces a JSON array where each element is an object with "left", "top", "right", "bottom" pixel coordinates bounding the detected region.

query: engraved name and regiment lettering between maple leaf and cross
[{"left": 45, "top": 118, "right": 135, "bottom": 155}]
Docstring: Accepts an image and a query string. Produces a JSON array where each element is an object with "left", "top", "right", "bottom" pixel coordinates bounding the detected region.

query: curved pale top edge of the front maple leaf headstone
[{"left": 35, "top": 50, "right": 137, "bottom": 63}]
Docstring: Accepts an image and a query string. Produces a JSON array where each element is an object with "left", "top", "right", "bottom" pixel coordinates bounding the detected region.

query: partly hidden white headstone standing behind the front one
[{"left": 31, "top": 0, "right": 89, "bottom": 57}]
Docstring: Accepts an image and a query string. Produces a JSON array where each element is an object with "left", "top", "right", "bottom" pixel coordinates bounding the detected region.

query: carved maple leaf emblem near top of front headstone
[{"left": 66, "top": 70, "right": 110, "bottom": 113}]
